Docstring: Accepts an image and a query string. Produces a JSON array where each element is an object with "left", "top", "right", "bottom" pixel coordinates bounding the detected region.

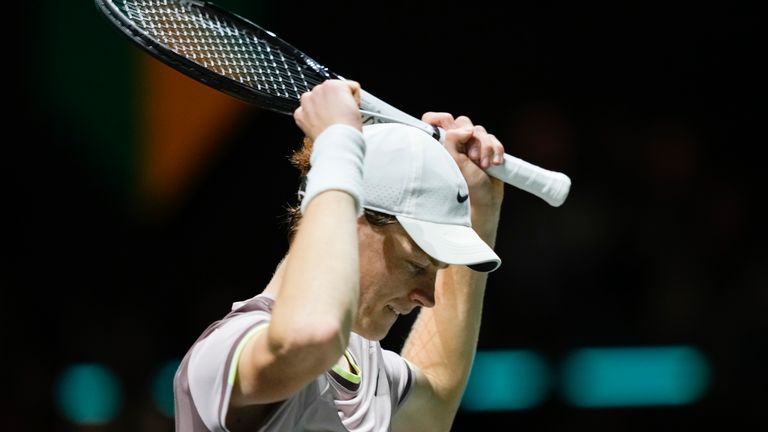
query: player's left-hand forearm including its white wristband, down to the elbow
[{"left": 269, "top": 121, "right": 365, "bottom": 370}]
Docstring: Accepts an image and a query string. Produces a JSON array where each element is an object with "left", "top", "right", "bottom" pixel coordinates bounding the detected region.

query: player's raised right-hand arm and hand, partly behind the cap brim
[{"left": 393, "top": 113, "right": 504, "bottom": 431}]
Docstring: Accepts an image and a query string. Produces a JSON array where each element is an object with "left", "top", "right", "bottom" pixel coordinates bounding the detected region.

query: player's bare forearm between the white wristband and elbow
[{"left": 270, "top": 191, "right": 359, "bottom": 369}]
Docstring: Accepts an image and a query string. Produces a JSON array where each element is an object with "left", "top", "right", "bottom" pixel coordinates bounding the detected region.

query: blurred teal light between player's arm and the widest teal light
[{"left": 461, "top": 350, "right": 550, "bottom": 411}]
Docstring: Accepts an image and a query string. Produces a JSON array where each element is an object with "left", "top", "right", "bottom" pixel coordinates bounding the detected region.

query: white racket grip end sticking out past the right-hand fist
[{"left": 486, "top": 154, "right": 571, "bottom": 207}]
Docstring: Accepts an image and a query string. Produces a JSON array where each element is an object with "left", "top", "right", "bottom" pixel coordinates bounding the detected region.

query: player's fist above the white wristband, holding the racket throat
[{"left": 293, "top": 80, "right": 363, "bottom": 140}]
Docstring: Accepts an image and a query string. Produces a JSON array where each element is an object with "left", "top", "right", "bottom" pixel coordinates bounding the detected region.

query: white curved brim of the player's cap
[{"left": 397, "top": 215, "right": 501, "bottom": 272}]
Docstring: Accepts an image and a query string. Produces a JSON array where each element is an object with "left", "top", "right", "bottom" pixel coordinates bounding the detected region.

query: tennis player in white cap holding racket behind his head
[{"left": 174, "top": 80, "right": 504, "bottom": 432}]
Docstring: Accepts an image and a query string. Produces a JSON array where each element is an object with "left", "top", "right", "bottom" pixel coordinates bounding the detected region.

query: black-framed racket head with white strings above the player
[{"left": 95, "top": 0, "right": 341, "bottom": 115}]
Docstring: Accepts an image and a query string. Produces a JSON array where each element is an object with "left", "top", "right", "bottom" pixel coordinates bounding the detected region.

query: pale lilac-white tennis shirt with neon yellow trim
[{"left": 173, "top": 293, "right": 413, "bottom": 432}]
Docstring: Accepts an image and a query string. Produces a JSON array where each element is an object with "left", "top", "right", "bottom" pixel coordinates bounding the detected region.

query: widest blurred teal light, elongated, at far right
[{"left": 562, "top": 346, "right": 710, "bottom": 408}]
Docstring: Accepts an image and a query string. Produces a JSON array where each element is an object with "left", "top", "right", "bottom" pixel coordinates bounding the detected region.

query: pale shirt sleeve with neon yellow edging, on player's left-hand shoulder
[{"left": 188, "top": 311, "right": 269, "bottom": 430}]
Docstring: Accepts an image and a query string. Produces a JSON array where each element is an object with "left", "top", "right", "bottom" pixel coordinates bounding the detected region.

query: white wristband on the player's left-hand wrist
[{"left": 301, "top": 124, "right": 365, "bottom": 216}]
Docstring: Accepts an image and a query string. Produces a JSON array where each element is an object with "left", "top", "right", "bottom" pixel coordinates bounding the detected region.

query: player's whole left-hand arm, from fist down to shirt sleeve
[{"left": 232, "top": 81, "right": 364, "bottom": 406}]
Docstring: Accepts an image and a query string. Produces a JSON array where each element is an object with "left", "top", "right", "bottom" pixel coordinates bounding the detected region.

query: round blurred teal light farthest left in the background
[{"left": 56, "top": 363, "right": 122, "bottom": 425}]
